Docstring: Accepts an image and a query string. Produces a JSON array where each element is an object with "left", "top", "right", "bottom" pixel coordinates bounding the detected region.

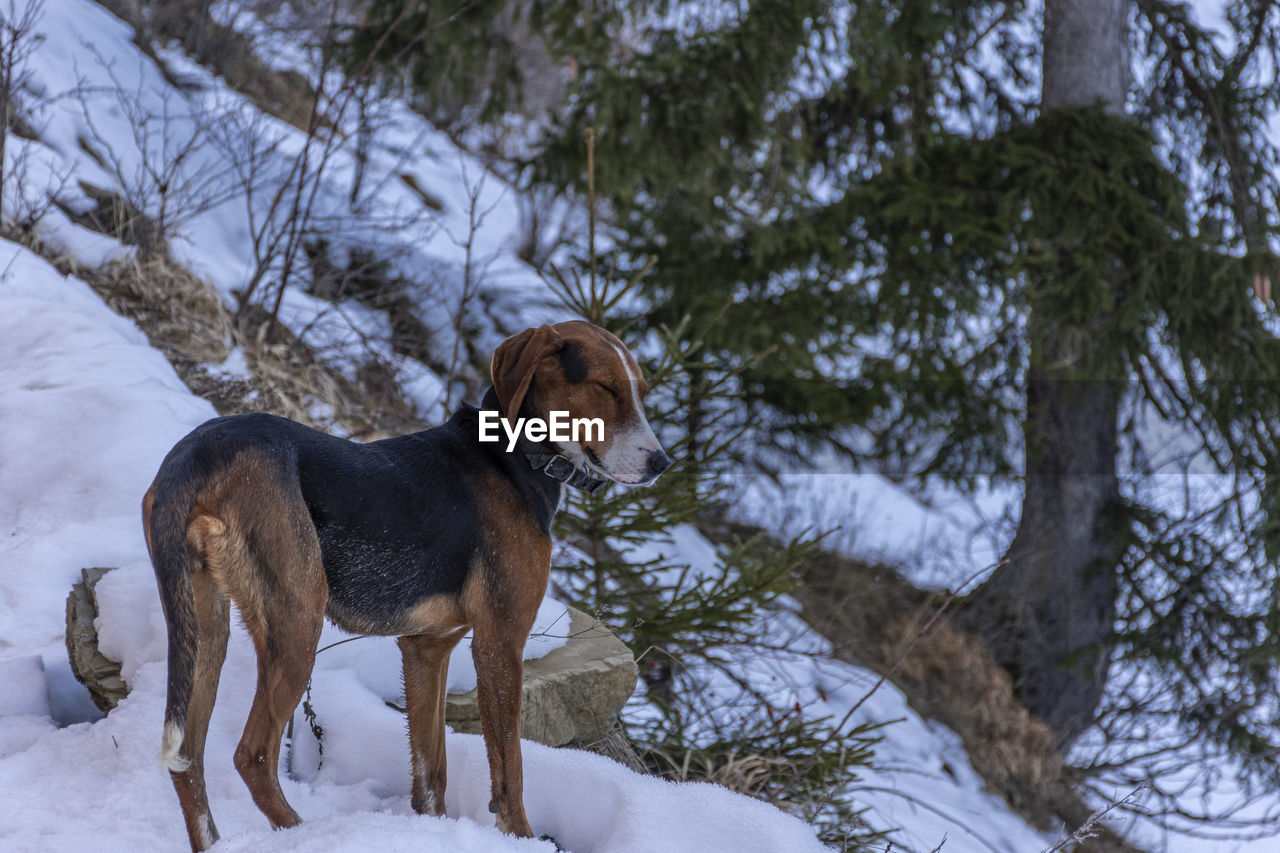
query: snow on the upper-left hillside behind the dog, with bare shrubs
[{"left": 4, "top": 0, "right": 563, "bottom": 402}]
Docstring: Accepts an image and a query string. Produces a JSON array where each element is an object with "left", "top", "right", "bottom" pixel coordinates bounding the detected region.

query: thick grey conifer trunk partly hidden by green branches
[{"left": 961, "top": 0, "right": 1128, "bottom": 749}]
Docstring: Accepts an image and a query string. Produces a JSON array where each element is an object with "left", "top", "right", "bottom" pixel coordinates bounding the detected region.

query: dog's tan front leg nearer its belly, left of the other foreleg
[{"left": 398, "top": 629, "right": 466, "bottom": 816}]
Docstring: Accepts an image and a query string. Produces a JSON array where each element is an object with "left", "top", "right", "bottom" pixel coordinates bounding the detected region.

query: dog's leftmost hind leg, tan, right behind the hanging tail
[{"left": 169, "top": 563, "right": 230, "bottom": 850}]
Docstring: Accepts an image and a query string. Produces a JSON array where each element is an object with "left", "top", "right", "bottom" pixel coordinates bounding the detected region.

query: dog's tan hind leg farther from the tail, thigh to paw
[{"left": 236, "top": 487, "right": 328, "bottom": 829}]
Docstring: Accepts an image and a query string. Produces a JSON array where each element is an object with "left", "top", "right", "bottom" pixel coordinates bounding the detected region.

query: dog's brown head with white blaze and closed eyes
[{"left": 492, "top": 320, "right": 671, "bottom": 485}]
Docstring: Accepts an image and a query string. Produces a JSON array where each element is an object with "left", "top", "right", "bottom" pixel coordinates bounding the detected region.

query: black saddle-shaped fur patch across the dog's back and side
[{"left": 148, "top": 406, "right": 561, "bottom": 634}]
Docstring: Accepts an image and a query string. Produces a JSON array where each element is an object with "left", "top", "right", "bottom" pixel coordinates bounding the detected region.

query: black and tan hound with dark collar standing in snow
[{"left": 142, "top": 320, "right": 671, "bottom": 850}]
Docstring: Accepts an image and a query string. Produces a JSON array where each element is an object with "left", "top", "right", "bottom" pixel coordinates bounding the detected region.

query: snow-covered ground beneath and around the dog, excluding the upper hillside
[{"left": 0, "top": 234, "right": 1046, "bottom": 852}]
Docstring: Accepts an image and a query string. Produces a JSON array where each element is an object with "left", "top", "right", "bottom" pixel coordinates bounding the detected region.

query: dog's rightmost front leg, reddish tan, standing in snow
[{"left": 471, "top": 620, "right": 534, "bottom": 836}]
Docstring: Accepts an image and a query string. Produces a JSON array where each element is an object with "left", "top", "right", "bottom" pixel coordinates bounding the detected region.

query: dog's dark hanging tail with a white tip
[{"left": 142, "top": 468, "right": 200, "bottom": 774}]
